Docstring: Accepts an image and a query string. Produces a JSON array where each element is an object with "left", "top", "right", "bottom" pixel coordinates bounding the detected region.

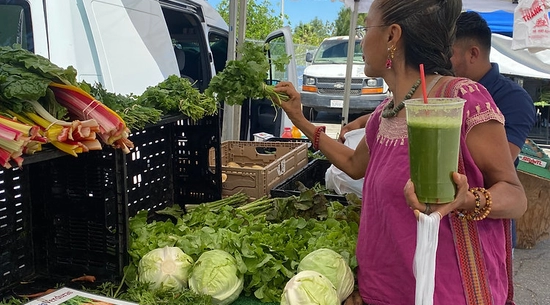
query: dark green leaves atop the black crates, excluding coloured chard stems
[{"left": 0, "top": 46, "right": 218, "bottom": 130}]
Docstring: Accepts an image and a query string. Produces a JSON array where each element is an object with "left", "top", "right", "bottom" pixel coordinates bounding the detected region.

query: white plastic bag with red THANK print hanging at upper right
[{"left": 512, "top": 0, "right": 550, "bottom": 53}]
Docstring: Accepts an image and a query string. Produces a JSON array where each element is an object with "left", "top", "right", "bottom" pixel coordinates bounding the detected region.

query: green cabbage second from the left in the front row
[{"left": 189, "top": 250, "right": 244, "bottom": 305}]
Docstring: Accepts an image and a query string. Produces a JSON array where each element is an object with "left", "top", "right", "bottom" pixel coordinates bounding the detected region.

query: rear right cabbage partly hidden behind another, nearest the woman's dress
[{"left": 298, "top": 248, "right": 355, "bottom": 302}]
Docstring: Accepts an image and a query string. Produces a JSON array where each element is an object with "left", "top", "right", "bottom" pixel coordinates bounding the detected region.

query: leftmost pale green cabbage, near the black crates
[{"left": 138, "top": 246, "right": 193, "bottom": 291}]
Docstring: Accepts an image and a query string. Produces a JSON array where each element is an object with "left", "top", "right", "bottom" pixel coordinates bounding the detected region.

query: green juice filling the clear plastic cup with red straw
[{"left": 407, "top": 117, "right": 461, "bottom": 203}]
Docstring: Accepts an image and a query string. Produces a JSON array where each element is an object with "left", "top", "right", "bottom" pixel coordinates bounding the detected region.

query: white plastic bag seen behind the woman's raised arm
[{"left": 325, "top": 128, "right": 365, "bottom": 198}]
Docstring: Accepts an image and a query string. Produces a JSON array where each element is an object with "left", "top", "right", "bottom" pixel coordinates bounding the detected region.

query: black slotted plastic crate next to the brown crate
[{"left": 125, "top": 115, "right": 222, "bottom": 215}]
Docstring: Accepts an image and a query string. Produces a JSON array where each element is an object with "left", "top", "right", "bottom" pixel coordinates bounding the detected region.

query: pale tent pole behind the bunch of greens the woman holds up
[{"left": 221, "top": 0, "right": 240, "bottom": 141}]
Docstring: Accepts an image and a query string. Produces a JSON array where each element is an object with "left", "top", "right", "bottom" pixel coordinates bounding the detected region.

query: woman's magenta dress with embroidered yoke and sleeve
[{"left": 357, "top": 79, "right": 508, "bottom": 305}]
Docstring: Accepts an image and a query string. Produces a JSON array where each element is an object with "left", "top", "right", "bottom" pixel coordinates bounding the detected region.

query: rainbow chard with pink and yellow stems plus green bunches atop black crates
[{"left": 0, "top": 46, "right": 218, "bottom": 168}]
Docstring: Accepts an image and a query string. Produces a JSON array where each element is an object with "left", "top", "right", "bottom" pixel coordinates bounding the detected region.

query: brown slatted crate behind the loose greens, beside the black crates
[{"left": 210, "top": 141, "right": 308, "bottom": 200}]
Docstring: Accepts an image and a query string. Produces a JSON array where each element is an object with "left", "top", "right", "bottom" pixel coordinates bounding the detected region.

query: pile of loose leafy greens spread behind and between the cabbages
[{"left": 126, "top": 191, "right": 358, "bottom": 302}]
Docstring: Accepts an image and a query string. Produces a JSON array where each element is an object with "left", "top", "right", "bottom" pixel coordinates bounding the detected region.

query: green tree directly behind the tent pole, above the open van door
[{"left": 216, "top": 0, "right": 288, "bottom": 40}]
